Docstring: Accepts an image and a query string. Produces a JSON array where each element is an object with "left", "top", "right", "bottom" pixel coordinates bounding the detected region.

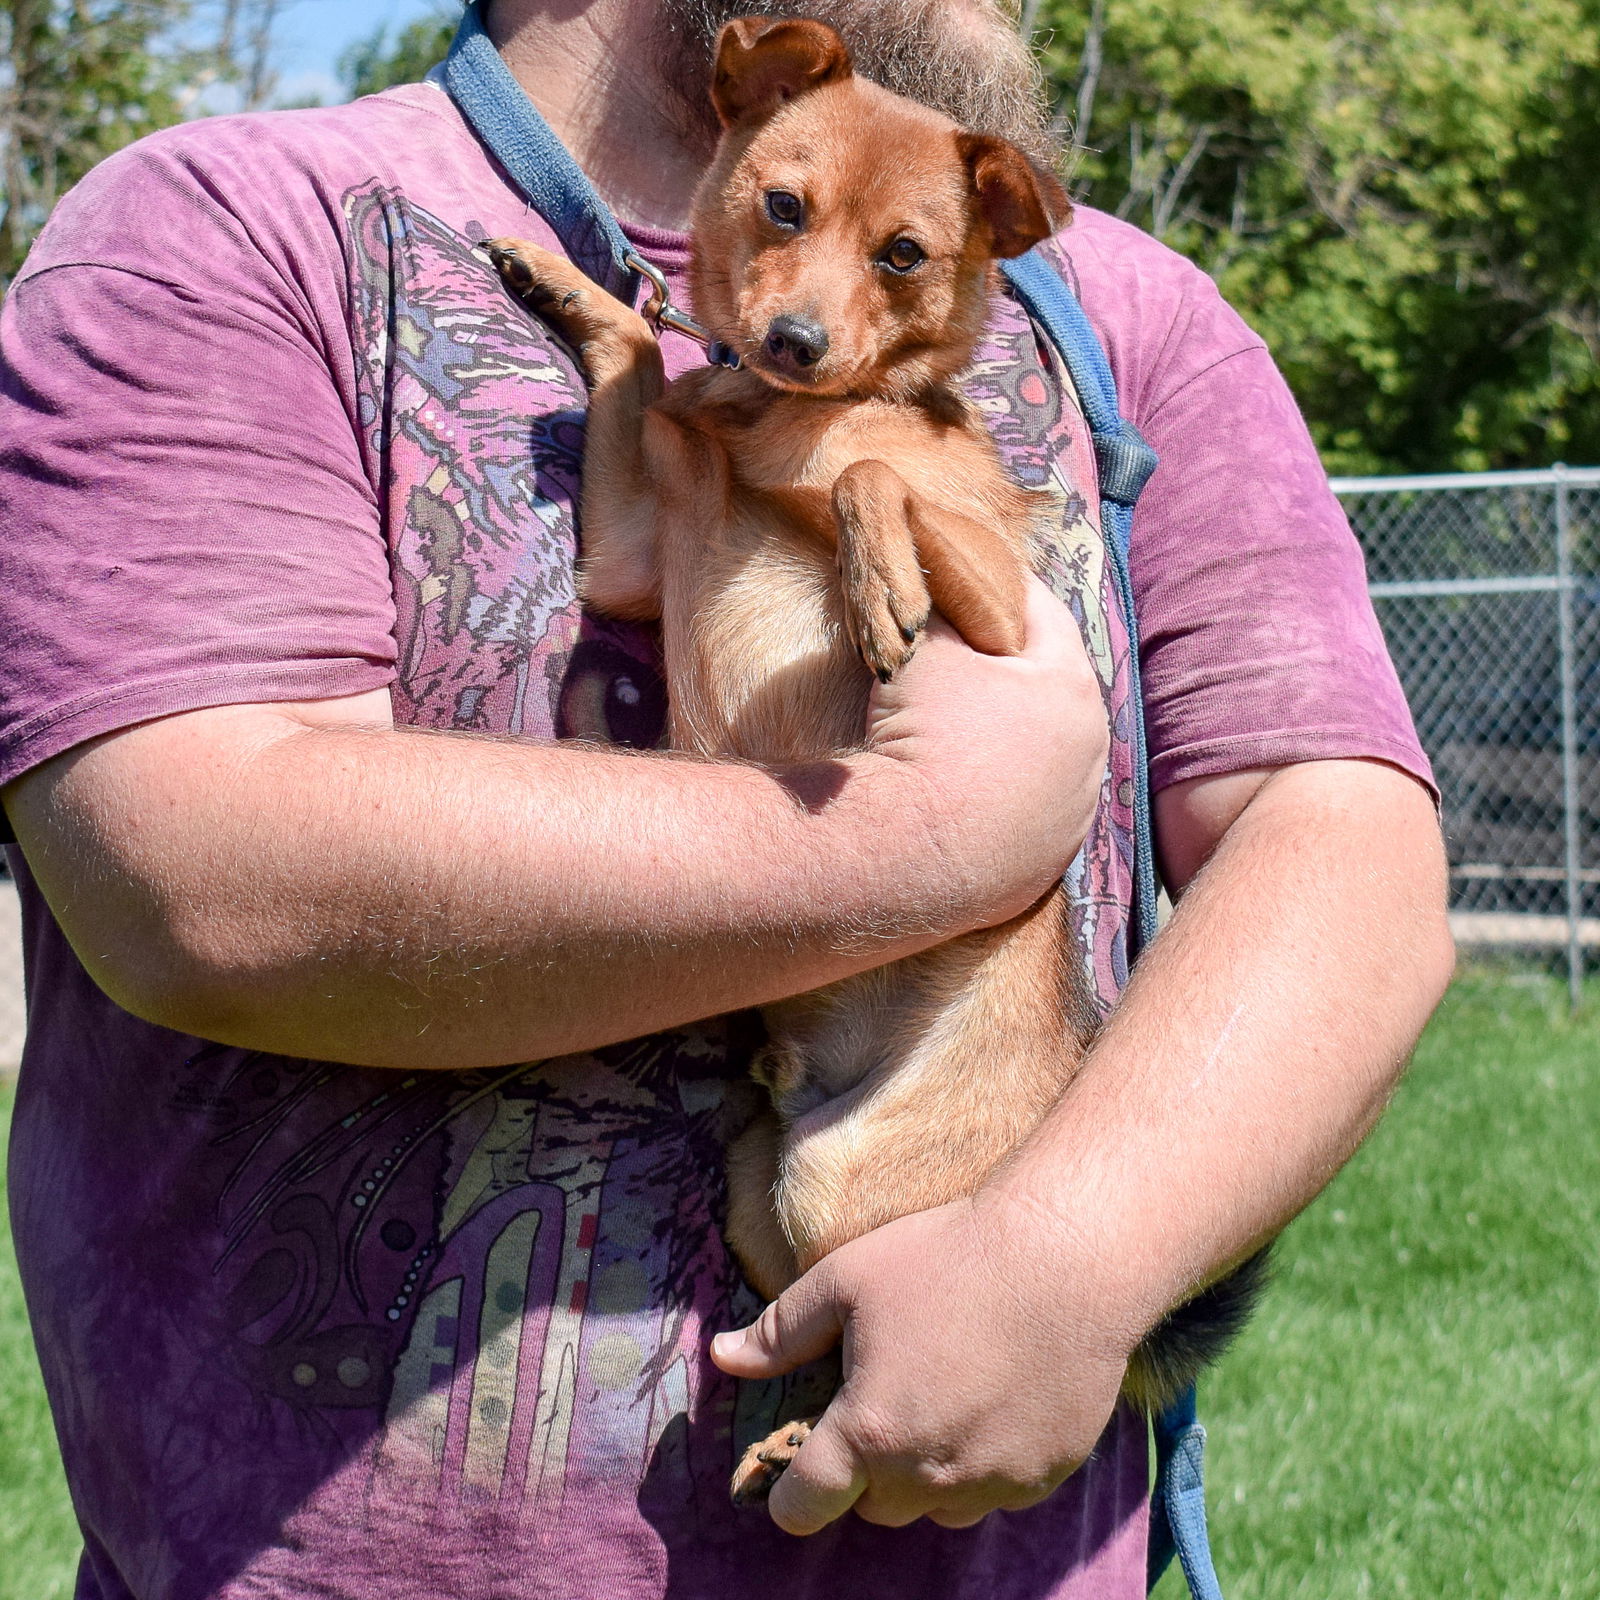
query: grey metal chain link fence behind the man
[{"left": 1333, "top": 467, "right": 1600, "bottom": 1005}]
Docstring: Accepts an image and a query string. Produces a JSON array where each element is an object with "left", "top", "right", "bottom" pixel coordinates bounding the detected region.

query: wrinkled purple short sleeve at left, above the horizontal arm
[{"left": 0, "top": 136, "right": 395, "bottom": 782}]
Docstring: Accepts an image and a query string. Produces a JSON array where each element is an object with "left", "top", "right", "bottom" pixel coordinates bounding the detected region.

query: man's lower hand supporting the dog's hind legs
[{"left": 712, "top": 1198, "right": 1138, "bottom": 1534}]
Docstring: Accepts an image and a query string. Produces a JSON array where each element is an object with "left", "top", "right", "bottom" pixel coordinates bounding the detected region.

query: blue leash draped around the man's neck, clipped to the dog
[{"left": 442, "top": 0, "right": 1222, "bottom": 1600}]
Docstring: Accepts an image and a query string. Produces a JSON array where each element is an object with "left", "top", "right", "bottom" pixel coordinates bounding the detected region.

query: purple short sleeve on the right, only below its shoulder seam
[{"left": 1131, "top": 339, "right": 1432, "bottom": 787}]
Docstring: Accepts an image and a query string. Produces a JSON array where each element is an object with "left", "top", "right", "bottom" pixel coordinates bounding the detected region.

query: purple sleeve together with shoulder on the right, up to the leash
[{"left": 1062, "top": 213, "right": 1432, "bottom": 789}]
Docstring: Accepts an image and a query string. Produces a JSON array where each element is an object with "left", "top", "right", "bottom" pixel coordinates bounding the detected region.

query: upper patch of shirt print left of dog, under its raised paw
[{"left": 344, "top": 186, "right": 666, "bottom": 747}]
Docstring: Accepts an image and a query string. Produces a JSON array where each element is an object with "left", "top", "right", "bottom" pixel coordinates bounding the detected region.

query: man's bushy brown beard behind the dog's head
[{"left": 658, "top": 0, "right": 1062, "bottom": 166}]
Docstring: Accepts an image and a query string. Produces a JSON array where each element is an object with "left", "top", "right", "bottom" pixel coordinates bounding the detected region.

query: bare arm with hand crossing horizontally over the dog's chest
[{"left": 5, "top": 582, "right": 1107, "bottom": 1067}]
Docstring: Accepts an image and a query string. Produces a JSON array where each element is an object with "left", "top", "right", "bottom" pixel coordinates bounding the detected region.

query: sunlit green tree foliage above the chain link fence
[{"left": 1037, "top": 0, "right": 1600, "bottom": 470}]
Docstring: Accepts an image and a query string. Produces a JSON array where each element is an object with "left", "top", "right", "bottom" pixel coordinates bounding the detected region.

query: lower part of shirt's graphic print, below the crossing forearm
[{"left": 189, "top": 1029, "right": 781, "bottom": 1512}]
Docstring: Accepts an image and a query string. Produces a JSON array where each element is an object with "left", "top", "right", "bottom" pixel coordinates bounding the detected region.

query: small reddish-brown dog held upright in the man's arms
[{"left": 490, "top": 18, "right": 1260, "bottom": 1498}]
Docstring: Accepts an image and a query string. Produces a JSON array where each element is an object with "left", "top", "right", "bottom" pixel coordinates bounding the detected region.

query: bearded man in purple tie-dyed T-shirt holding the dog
[{"left": 0, "top": 0, "right": 1451, "bottom": 1600}]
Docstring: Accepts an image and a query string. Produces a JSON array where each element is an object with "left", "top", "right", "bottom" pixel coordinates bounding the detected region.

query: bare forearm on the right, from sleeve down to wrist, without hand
[{"left": 986, "top": 762, "right": 1453, "bottom": 1338}]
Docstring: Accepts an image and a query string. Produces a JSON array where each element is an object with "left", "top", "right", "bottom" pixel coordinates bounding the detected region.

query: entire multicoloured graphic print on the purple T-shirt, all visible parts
[{"left": 190, "top": 178, "right": 1131, "bottom": 1528}]
